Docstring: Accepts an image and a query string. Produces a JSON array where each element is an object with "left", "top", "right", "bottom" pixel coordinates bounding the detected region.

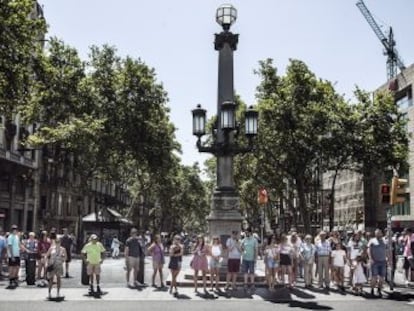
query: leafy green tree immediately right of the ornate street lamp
[{"left": 257, "top": 59, "right": 346, "bottom": 232}]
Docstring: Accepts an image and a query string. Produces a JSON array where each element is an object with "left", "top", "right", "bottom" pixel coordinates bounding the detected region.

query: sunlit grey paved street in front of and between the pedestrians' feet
[{"left": 0, "top": 256, "right": 414, "bottom": 311}]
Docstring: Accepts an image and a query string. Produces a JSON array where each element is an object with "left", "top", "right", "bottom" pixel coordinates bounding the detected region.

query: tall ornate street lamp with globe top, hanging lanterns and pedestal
[{"left": 192, "top": 4, "right": 258, "bottom": 238}]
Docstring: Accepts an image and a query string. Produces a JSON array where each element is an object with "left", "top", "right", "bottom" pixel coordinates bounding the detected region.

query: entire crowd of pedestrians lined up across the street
[{"left": 0, "top": 226, "right": 414, "bottom": 297}]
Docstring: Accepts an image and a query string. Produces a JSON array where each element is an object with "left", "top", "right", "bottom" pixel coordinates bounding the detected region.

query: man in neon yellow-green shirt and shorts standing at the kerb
[{"left": 81, "top": 234, "right": 105, "bottom": 294}]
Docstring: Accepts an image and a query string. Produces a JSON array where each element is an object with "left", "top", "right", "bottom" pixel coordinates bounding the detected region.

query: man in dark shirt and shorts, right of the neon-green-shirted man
[{"left": 124, "top": 228, "right": 143, "bottom": 287}]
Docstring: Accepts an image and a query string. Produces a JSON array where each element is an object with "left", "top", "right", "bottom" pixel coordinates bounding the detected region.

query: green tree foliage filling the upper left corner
[{"left": 0, "top": 0, "right": 46, "bottom": 119}]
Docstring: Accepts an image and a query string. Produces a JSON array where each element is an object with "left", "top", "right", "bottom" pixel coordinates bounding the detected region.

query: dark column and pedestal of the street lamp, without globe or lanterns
[{"left": 207, "top": 29, "right": 243, "bottom": 241}]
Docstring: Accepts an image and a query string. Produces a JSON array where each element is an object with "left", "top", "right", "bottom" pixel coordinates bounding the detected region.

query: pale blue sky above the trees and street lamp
[{"left": 38, "top": 0, "right": 414, "bottom": 165}]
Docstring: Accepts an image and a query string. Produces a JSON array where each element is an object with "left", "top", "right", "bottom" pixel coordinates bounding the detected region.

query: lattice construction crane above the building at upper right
[{"left": 356, "top": 0, "right": 405, "bottom": 80}]
